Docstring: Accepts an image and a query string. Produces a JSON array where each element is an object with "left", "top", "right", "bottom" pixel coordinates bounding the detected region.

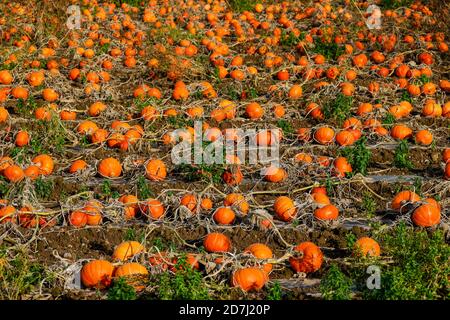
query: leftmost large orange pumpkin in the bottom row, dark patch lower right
[{"left": 80, "top": 260, "right": 114, "bottom": 289}]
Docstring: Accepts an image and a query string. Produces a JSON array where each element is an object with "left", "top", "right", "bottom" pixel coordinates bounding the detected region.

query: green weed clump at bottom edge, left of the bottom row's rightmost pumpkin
[{"left": 158, "top": 256, "right": 209, "bottom": 300}]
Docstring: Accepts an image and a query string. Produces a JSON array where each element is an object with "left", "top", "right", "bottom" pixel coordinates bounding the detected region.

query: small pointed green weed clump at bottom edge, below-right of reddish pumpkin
[{"left": 320, "top": 264, "right": 352, "bottom": 300}]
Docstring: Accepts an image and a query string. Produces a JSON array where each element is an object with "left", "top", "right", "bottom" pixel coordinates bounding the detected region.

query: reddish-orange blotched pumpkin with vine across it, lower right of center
[{"left": 289, "top": 242, "right": 323, "bottom": 273}]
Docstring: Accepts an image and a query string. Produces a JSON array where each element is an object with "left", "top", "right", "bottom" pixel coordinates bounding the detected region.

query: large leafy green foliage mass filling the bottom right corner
[{"left": 364, "top": 223, "right": 450, "bottom": 300}]
